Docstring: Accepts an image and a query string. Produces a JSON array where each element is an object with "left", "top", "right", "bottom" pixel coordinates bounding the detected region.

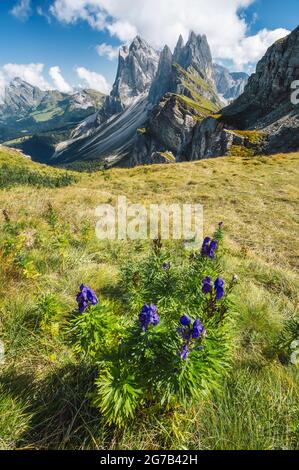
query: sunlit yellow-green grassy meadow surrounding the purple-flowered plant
[{"left": 0, "top": 153, "right": 299, "bottom": 449}]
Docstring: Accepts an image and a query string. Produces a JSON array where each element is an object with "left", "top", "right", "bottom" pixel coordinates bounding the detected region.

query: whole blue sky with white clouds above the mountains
[{"left": 0, "top": 0, "right": 299, "bottom": 91}]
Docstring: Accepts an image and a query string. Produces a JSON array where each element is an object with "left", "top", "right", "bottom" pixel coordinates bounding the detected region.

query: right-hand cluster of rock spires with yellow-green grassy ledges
[{"left": 131, "top": 33, "right": 221, "bottom": 164}]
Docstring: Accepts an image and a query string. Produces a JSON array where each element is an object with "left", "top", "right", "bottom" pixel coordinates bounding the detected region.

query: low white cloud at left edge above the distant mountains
[{"left": 0, "top": 64, "right": 53, "bottom": 90}]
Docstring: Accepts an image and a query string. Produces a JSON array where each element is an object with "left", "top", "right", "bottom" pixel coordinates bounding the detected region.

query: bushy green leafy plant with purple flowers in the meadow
[{"left": 71, "top": 229, "right": 234, "bottom": 427}]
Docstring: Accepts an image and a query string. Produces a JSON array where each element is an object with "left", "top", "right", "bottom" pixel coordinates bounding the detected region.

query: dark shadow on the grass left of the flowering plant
[{"left": 1, "top": 364, "right": 113, "bottom": 450}]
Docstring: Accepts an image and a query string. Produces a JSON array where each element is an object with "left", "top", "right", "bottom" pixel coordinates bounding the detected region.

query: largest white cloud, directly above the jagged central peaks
[{"left": 51, "top": 0, "right": 288, "bottom": 69}]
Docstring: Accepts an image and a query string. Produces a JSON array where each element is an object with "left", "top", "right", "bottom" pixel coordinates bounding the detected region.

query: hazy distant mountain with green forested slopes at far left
[{"left": 0, "top": 78, "right": 105, "bottom": 161}]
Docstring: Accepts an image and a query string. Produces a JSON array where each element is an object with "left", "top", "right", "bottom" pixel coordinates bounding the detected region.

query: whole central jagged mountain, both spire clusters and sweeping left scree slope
[{"left": 53, "top": 33, "right": 221, "bottom": 166}]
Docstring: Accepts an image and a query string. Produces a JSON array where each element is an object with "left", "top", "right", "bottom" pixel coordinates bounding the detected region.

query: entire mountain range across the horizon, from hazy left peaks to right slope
[{"left": 0, "top": 27, "right": 299, "bottom": 170}]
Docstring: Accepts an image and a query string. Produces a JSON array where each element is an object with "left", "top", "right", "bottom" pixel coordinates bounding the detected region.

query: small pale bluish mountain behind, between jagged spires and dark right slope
[{"left": 214, "top": 64, "right": 249, "bottom": 104}]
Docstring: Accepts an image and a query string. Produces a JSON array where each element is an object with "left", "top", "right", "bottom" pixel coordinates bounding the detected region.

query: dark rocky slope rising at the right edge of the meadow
[{"left": 222, "top": 27, "right": 299, "bottom": 153}]
